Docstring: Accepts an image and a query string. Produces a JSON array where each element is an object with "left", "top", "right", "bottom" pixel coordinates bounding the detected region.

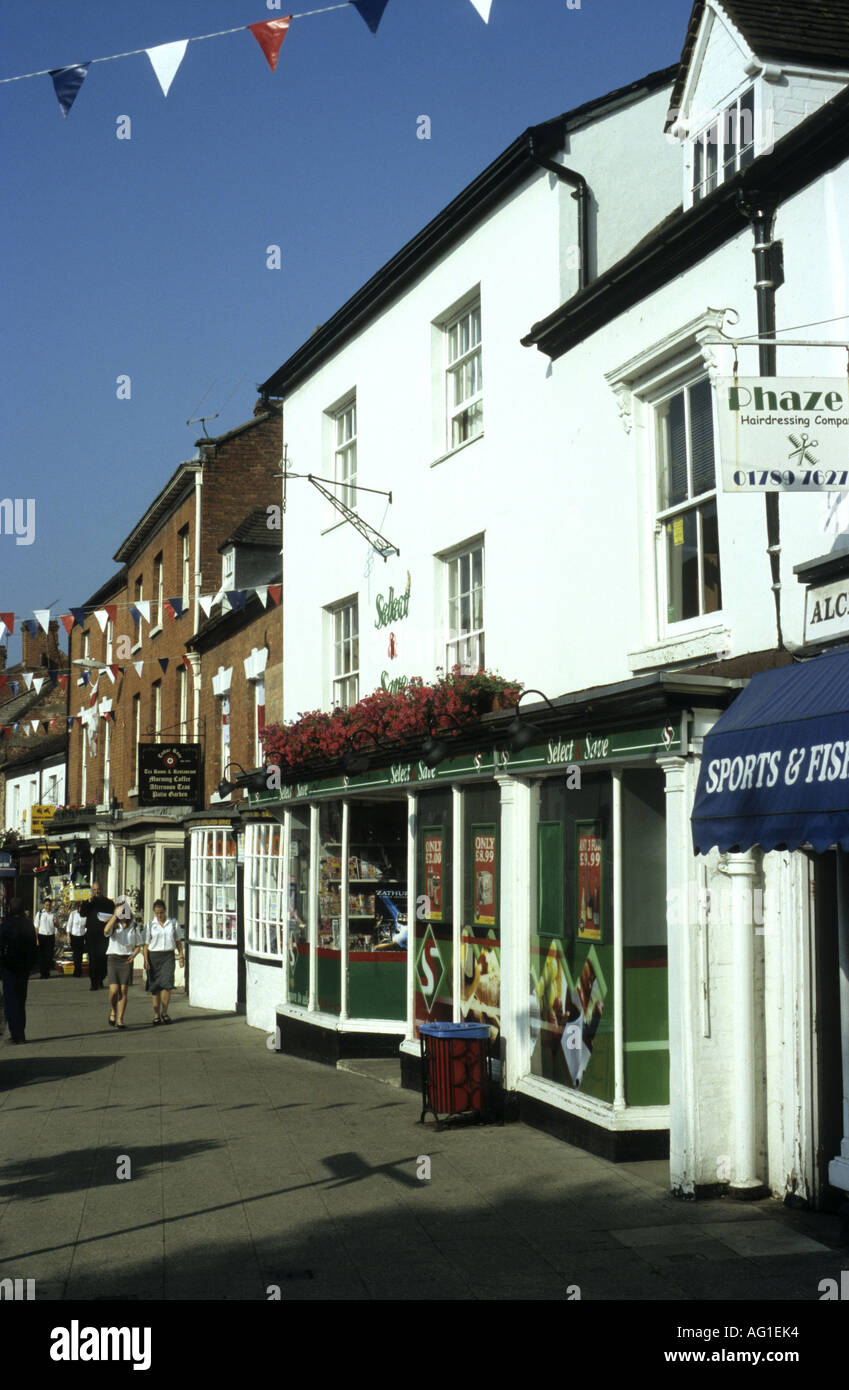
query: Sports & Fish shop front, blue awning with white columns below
[{"left": 692, "top": 649, "right": 849, "bottom": 1207}]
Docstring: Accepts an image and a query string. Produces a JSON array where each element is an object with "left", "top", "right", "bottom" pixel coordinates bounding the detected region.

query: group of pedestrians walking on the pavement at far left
[{"left": 0, "top": 883, "right": 185, "bottom": 1044}]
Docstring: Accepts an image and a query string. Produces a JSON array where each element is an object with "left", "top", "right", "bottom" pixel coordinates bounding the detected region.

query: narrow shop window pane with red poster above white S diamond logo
[{"left": 414, "top": 791, "right": 454, "bottom": 1037}]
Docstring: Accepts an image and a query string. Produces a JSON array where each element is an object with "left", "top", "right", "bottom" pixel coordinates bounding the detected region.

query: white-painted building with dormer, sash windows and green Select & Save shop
[{"left": 190, "top": 0, "right": 849, "bottom": 1202}]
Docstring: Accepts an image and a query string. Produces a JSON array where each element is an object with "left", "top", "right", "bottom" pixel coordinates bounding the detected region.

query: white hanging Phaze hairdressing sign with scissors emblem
[{"left": 717, "top": 377, "right": 849, "bottom": 492}]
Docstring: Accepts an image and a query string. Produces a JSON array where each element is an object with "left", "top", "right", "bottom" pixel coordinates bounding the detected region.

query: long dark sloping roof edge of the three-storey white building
[{"left": 258, "top": 67, "right": 675, "bottom": 396}]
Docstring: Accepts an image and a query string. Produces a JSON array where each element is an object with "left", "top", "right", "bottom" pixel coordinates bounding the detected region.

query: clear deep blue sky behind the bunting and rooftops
[{"left": 0, "top": 0, "right": 691, "bottom": 662}]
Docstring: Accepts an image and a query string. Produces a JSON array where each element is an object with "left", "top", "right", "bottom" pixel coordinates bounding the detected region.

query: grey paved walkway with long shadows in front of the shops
[{"left": 0, "top": 977, "right": 849, "bottom": 1302}]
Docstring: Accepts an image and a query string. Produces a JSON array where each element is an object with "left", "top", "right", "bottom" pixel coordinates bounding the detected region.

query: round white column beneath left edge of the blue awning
[{"left": 725, "top": 851, "right": 763, "bottom": 1197}]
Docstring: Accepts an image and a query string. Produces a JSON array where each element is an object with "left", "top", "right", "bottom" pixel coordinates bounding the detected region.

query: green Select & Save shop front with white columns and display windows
[{"left": 252, "top": 677, "right": 728, "bottom": 1158}]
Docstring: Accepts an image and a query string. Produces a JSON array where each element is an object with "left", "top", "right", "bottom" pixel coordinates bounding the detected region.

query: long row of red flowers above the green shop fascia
[{"left": 261, "top": 666, "right": 522, "bottom": 771}]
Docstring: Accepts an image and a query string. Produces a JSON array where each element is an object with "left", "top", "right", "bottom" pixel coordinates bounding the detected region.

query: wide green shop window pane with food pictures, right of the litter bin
[{"left": 531, "top": 774, "right": 614, "bottom": 1104}]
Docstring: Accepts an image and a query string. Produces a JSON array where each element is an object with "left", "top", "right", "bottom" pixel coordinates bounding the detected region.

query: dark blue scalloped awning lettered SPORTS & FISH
[{"left": 692, "top": 651, "right": 849, "bottom": 853}]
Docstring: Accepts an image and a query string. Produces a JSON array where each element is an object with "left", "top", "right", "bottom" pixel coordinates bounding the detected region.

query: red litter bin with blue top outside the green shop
[{"left": 418, "top": 1023, "right": 489, "bottom": 1126}]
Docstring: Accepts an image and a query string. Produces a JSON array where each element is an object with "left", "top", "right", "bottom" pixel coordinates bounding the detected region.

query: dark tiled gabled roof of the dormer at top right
[{"left": 670, "top": 0, "right": 849, "bottom": 111}]
